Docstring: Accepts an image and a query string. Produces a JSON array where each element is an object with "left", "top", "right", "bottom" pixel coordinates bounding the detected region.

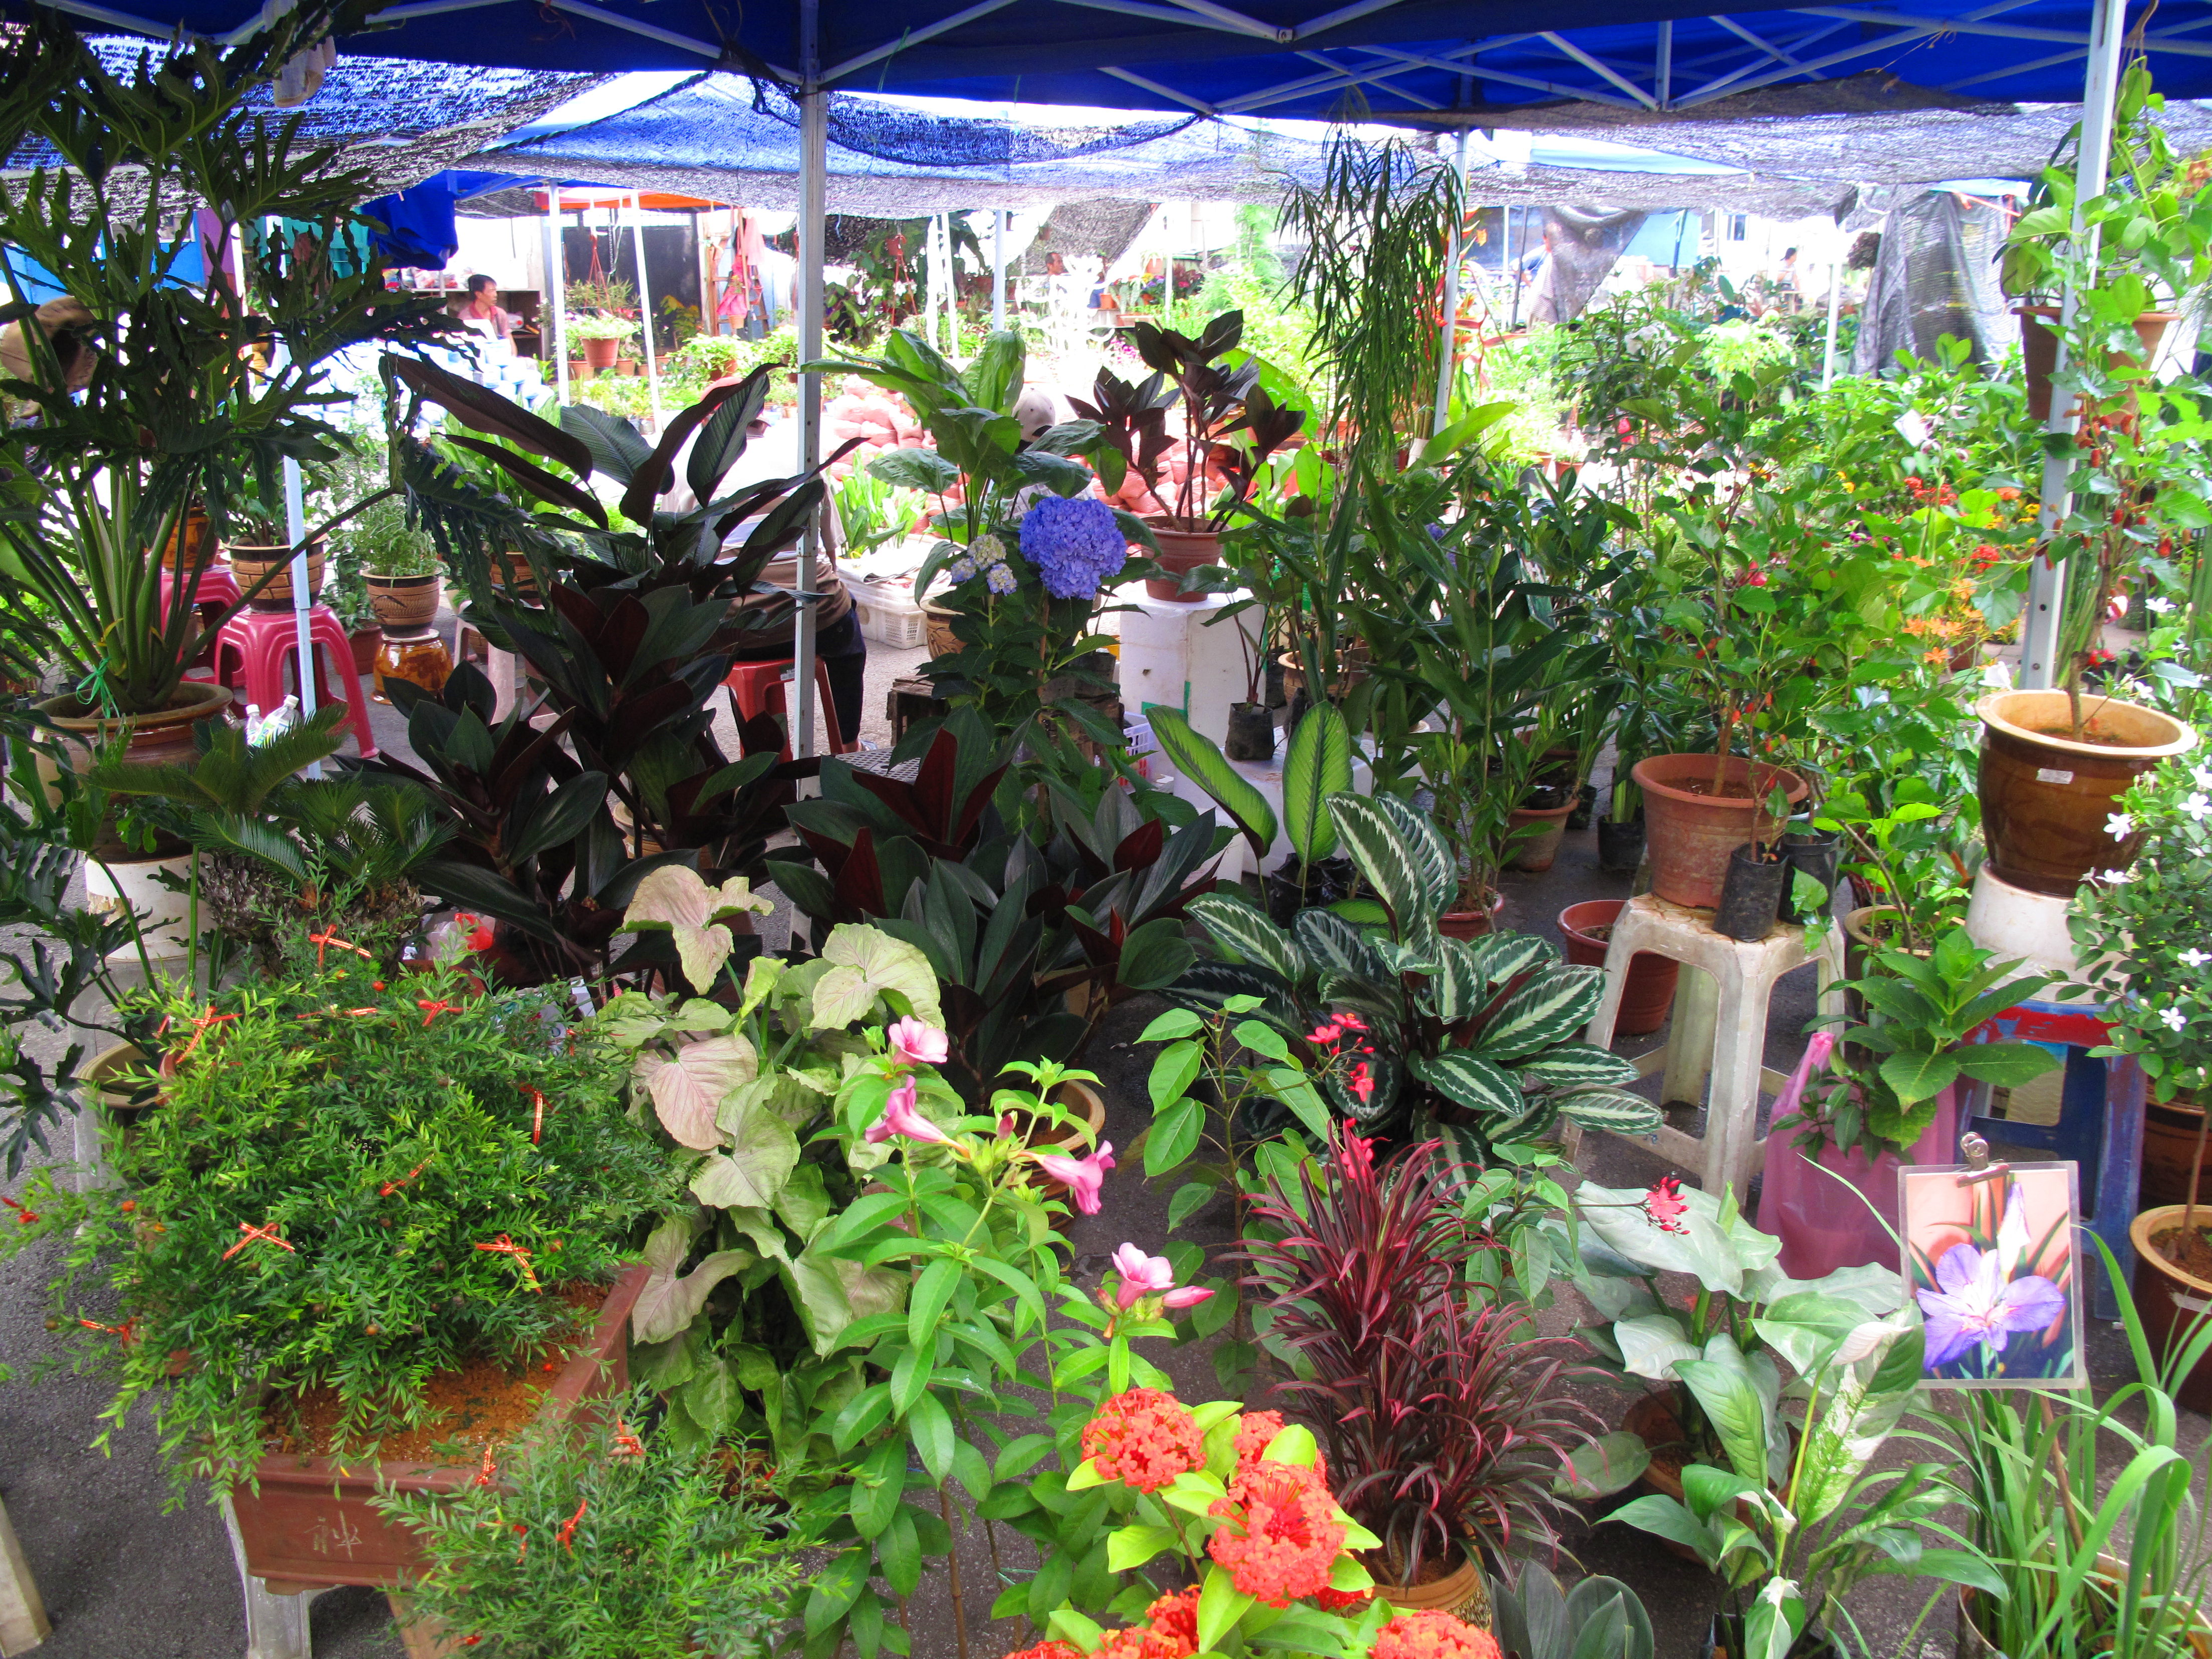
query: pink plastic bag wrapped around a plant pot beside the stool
[{"left": 1759, "top": 1031, "right": 1958, "bottom": 1278}]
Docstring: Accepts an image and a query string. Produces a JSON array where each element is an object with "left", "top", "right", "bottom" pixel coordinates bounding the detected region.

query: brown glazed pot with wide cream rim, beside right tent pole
[{"left": 1973, "top": 690, "right": 2196, "bottom": 898}]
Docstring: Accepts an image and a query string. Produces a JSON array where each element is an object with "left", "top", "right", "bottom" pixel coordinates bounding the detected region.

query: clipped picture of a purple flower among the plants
[{"left": 1898, "top": 1164, "right": 2088, "bottom": 1389}]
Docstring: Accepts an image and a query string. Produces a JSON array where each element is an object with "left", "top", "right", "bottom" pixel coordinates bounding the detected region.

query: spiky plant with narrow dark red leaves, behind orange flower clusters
[{"left": 1241, "top": 1126, "right": 1601, "bottom": 1584}]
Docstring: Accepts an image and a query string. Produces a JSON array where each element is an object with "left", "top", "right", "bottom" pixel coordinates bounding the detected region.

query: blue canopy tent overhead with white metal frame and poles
[{"left": 0, "top": 0, "right": 2159, "bottom": 721}]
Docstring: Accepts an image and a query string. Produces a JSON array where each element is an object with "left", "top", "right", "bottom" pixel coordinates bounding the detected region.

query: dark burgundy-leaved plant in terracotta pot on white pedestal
[{"left": 1070, "top": 312, "right": 1305, "bottom": 602}]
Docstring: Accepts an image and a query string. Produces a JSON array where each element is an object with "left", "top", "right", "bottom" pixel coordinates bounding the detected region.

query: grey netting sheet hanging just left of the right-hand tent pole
[{"left": 1851, "top": 190, "right": 2020, "bottom": 374}]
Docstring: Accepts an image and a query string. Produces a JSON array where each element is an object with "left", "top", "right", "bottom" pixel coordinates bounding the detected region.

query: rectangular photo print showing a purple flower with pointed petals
[{"left": 1907, "top": 1170, "right": 2077, "bottom": 1385}]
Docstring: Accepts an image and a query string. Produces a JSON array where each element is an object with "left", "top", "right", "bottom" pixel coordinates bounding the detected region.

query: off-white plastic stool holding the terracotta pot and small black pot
[{"left": 1566, "top": 894, "right": 1843, "bottom": 1203}]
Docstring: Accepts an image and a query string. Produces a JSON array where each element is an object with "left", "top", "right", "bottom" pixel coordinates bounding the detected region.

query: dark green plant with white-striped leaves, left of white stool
[{"left": 1168, "top": 794, "right": 1659, "bottom": 1164}]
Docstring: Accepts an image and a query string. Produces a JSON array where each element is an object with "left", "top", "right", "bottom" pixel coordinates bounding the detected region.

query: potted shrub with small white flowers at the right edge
[{"left": 2064, "top": 761, "right": 2212, "bottom": 1219}]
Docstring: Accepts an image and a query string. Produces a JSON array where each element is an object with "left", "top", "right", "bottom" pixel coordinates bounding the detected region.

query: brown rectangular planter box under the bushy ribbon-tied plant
[{"left": 230, "top": 1263, "right": 648, "bottom": 1595}]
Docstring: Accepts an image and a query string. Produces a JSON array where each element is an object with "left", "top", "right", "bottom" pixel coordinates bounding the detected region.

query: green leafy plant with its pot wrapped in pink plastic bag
[{"left": 1759, "top": 927, "right": 2059, "bottom": 1278}]
